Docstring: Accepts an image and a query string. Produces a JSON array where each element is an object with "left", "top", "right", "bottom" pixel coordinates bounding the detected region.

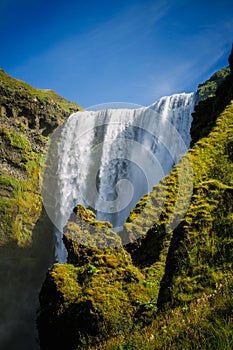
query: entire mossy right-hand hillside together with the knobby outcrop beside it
[{"left": 38, "top": 47, "right": 233, "bottom": 349}]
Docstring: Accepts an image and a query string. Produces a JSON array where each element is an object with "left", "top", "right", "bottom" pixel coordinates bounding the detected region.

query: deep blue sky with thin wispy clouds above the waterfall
[{"left": 0, "top": 0, "right": 233, "bottom": 108}]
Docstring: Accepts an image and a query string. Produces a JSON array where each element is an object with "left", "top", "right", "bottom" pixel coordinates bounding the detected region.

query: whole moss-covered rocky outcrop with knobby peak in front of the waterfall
[{"left": 37, "top": 208, "right": 155, "bottom": 350}]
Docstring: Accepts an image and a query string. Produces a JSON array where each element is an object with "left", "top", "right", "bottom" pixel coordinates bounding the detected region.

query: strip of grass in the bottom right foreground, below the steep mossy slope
[{"left": 84, "top": 276, "right": 233, "bottom": 350}]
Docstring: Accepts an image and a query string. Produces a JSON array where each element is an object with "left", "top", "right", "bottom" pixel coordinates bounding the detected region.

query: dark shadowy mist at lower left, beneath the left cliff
[{"left": 0, "top": 210, "right": 53, "bottom": 350}]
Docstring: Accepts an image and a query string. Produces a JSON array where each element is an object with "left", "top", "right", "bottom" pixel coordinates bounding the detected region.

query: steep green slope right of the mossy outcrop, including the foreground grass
[{"left": 83, "top": 76, "right": 233, "bottom": 350}]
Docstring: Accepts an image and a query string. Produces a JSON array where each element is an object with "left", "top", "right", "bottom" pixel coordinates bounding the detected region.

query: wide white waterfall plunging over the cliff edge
[{"left": 43, "top": 93, "right": 195, "bottom": 262}]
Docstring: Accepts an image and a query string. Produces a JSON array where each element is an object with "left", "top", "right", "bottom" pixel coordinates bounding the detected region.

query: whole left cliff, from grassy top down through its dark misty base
[{"left": 0, "top": 70, "right": 83, "bottom": 349}]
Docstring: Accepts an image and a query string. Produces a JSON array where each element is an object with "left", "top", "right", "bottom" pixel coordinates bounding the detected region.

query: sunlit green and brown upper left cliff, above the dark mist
[{"left": 0, "top": 70, "right": 81, "bottom": 247}]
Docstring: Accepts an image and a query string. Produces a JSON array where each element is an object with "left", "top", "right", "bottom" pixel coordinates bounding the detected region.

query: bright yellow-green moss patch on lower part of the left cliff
[{"left": 0, "top": 129, "right": 42, "bottom": 246}]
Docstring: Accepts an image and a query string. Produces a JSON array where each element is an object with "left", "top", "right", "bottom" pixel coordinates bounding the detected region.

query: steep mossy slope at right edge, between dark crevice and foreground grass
[{"left": 159, "top": 103, "right": 233, "bottom": 305}]
